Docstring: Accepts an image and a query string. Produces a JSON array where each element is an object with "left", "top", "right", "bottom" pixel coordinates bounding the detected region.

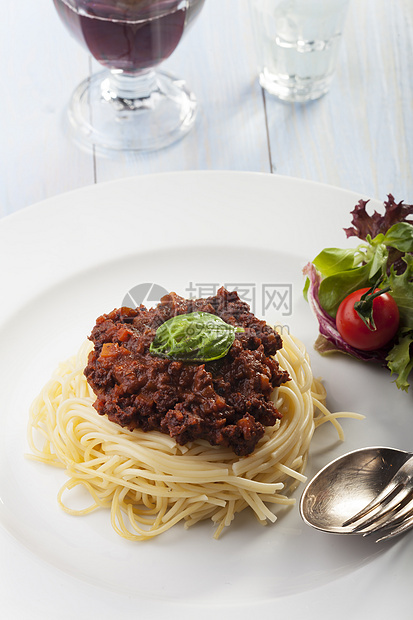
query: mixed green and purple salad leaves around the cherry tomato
[{"left": 304, "top": 194, "right": 413, "bottom": 391}]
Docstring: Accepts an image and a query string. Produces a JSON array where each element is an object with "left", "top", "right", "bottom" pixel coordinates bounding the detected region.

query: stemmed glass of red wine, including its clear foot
[{"left": 53, "top": 0, "right": 204, "bottom": 151}]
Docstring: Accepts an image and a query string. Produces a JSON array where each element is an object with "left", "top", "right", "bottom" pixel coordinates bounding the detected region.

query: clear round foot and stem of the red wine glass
[{"left": 69, "top": 70, "right": 197, "bottom": 151}]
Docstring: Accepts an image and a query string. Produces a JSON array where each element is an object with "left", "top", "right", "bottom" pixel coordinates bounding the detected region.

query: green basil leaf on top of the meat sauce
[{"left": 149, "top": 312, "right": 244, "bottom": 362}]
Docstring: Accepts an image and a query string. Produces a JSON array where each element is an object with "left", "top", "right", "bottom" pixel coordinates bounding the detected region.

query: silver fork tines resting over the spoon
[{"left": 343, "top": 456, "right": 413, "bottom": 540}]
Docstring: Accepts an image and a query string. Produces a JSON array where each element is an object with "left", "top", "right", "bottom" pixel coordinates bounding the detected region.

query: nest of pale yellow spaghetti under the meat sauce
[{"left": 28, "top": 334, "right": 362, "bottom": 540}]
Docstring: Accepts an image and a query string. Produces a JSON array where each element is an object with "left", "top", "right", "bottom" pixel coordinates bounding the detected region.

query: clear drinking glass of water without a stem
[{"left": 250, "top": 0, "right": 349, "bottom": 102}]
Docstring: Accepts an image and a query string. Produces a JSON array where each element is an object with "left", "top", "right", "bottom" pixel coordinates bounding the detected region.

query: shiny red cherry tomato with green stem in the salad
[{"left": 336, "top": 288, "right": 399, "bottom": 351}]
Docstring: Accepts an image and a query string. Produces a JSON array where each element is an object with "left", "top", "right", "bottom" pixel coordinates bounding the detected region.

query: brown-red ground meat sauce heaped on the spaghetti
[{"left": 85, "top": 288, "right": 289, "bottom": 456}]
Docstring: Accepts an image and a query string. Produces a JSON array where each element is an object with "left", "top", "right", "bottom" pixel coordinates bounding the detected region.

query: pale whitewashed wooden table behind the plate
[{"left": 0, "top": 0, "right": 413, "bottom": 216}]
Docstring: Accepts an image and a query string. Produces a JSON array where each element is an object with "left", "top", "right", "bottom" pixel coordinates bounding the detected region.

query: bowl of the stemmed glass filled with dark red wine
[{"left": 53, "top": 0, "right": 204, "bottom": 73}]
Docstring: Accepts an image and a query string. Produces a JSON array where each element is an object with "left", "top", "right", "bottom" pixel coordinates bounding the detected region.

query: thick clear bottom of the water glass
[{"left": 259, "top": 69, "right": 333, "bottom": 103}]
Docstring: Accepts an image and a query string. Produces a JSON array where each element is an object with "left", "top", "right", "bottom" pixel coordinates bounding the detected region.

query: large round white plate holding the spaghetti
[{"left": 0, "top": 172, "right": 413, "bottom": 620}]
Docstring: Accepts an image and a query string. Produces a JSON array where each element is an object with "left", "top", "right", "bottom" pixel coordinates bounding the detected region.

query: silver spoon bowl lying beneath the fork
[{"left": 300, "top": 447, "right": 412, "bottom": 535}]
